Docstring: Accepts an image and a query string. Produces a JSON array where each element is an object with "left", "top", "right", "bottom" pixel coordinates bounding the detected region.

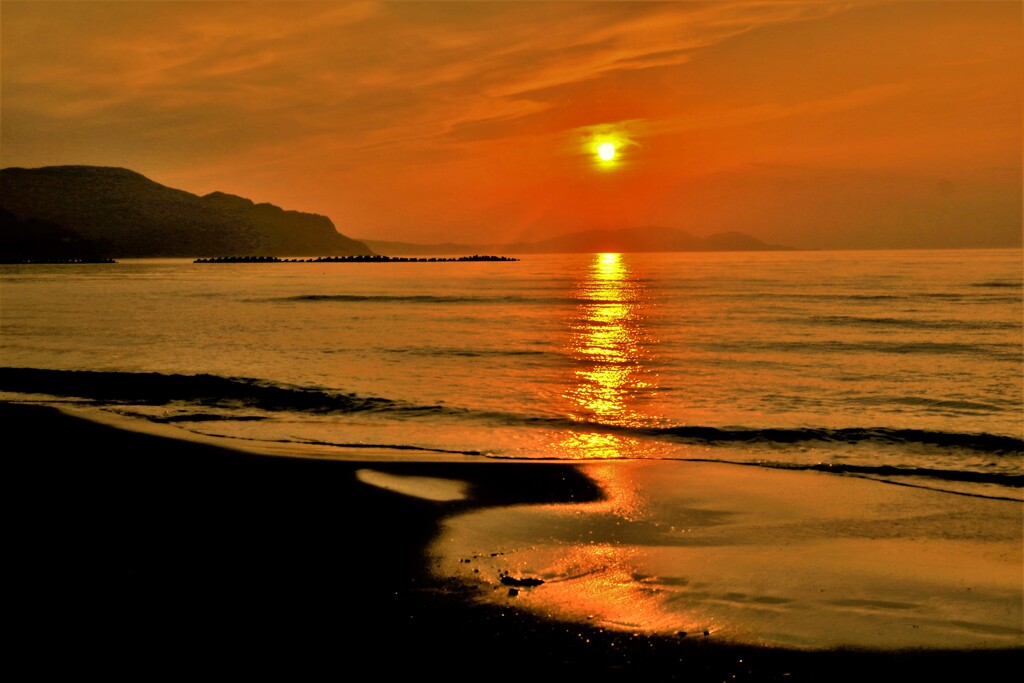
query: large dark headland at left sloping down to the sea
[{"left": 0, "top": 166, "right": 373, "bottom": 258}]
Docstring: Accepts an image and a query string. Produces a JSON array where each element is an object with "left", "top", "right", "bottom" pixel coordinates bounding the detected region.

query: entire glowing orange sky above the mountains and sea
[{"left": 0, "top": 0, "right": 1024, "bottom": 248}]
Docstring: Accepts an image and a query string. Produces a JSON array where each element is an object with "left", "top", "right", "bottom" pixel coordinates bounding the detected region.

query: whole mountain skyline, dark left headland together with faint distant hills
[{"left": 0, "top": 166, "right": 790, "bottom": 262}]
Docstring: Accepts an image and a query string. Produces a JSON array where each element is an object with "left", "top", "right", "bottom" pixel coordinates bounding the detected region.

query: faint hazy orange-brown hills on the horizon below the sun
[{"left": 364, "top": 227, "right": 790, "bottom": 255}]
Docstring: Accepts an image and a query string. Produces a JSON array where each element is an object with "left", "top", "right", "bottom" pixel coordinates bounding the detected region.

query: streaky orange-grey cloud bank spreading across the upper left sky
[{"left": 3, "top": 2, "right": 851, "bottom": 156}]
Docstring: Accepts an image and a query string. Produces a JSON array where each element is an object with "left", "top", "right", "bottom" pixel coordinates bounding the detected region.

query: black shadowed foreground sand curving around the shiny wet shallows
[{"left": 6, "top": 403, "right": 1024, "bottom": 681}]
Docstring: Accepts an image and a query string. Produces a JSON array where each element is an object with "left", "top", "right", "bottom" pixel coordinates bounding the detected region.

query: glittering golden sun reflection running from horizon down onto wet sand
[{"left": 509, "top": 253, "right": 696, "bottom": 629}]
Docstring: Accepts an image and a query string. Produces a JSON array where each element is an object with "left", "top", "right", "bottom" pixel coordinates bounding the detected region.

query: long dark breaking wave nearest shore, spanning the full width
[{"left": 0, "top": 368, "right": 1024, "bottom": 456}]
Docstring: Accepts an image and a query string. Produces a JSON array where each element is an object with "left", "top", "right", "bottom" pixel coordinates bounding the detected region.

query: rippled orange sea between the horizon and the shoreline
[{"left": 0, "top": 250, "right": 1024, "bottom": 500}]
